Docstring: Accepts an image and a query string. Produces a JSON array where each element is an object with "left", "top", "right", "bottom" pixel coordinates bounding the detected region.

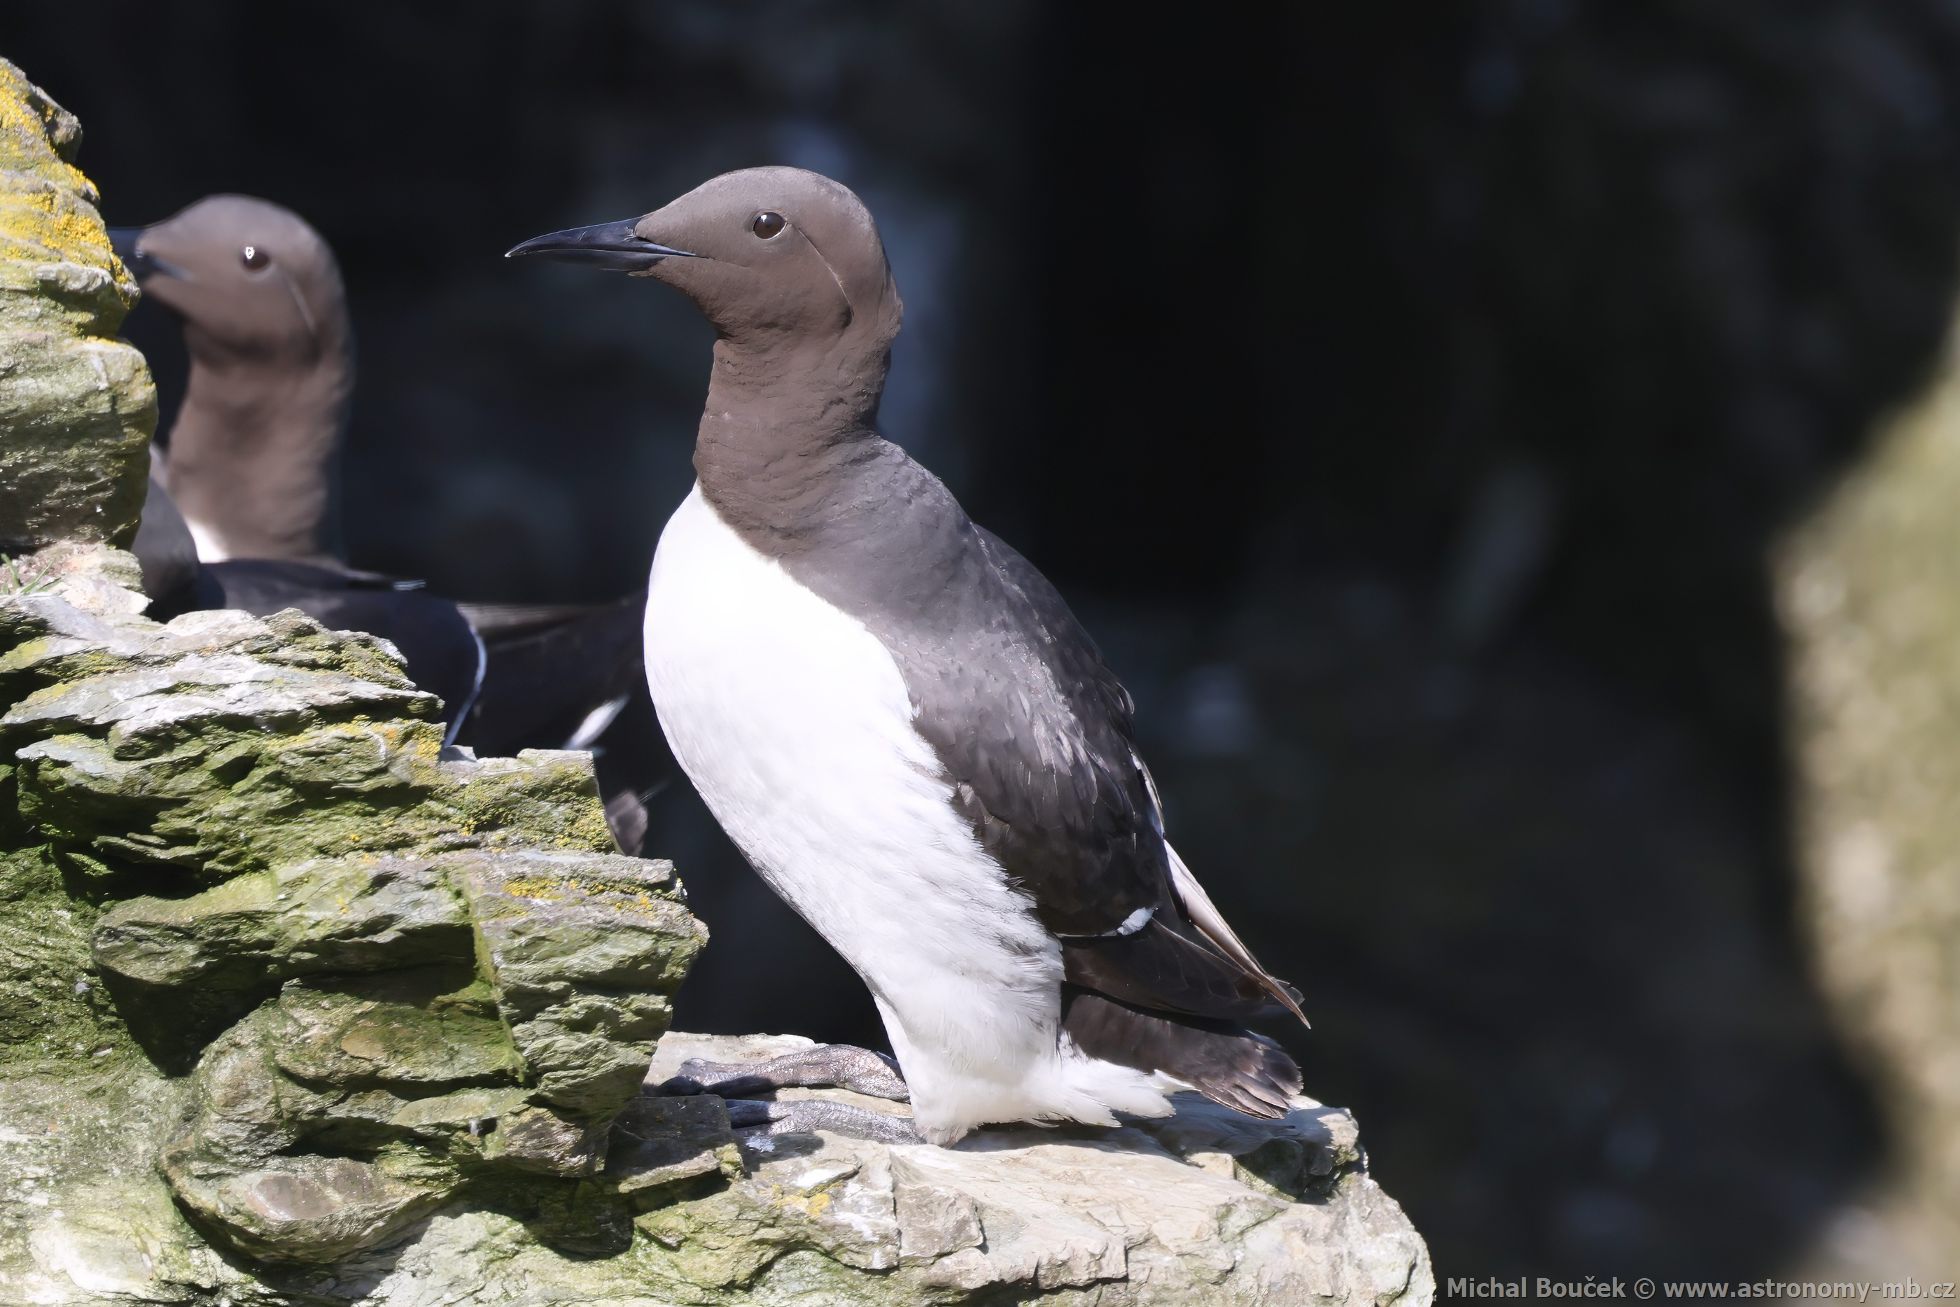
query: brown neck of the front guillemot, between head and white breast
[{"left": 694, "top": 337, "right": 890, "bottom": 553}]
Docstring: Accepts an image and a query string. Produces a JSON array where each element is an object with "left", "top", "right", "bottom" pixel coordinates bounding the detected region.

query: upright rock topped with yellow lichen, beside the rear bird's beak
[{"left": 0, "top": 59, "right": 157, "bottom": 553}]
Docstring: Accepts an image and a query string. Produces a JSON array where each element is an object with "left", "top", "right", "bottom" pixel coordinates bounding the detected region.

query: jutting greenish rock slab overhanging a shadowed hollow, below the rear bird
[{"left": 94, "top": 848, "right": 700, "bottom": 1081}]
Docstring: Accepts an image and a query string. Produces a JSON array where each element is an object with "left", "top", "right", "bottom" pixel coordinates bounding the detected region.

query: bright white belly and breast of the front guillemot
[{"left": 647, "top": 486, "right": 1162, "bottom": 1138}]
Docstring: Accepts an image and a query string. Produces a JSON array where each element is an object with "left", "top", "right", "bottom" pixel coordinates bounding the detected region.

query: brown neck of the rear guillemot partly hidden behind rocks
[{"left": 169, "top": 337, "right": 353, "bottom": 562}]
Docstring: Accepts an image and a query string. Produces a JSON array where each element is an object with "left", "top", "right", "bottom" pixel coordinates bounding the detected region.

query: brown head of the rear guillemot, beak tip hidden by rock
[{"left": 110, "top": 196, "right": 347, "bottom": 364}]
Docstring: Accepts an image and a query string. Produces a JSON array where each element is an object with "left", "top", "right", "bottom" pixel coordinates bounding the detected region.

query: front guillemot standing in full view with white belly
[{"left": 510, "top": 169, "right": 1305, "bottom": 1144}]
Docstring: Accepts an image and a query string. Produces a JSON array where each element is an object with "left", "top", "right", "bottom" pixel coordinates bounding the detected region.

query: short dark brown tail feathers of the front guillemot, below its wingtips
[{"left": 1062, "top": 986, "right": 1299, "bottom": 1119}]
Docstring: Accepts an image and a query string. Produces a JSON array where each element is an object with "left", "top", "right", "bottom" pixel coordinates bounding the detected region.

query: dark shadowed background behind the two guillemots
[{"left": 0, "top": 0, "right": 1960, "bottom": 1278}]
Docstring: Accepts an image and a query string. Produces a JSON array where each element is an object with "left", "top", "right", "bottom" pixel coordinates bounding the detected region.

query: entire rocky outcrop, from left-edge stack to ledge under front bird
[{"left": 0, "top": 65, "right": 1433, "bottom": 1307}]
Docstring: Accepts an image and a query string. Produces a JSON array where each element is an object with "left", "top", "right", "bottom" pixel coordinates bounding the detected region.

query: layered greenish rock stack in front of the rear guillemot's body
[{"left": 0, "top": 547, "right": 706, "bottom": 1277}]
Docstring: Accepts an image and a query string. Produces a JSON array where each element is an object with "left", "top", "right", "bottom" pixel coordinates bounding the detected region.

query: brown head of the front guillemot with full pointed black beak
[{"left": 506, "top": 169, "right": 904, "bottom": 349}]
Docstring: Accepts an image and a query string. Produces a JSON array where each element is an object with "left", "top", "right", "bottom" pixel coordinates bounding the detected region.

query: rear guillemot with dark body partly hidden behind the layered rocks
[{"left": 112, "top": 196, "right": 659, "bottom": 807}]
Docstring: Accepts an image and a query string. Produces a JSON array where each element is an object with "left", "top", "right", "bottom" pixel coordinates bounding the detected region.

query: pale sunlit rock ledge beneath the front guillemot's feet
[{"left": 619, "top": 1035, "right": 1435, "bottom": 1307}]
